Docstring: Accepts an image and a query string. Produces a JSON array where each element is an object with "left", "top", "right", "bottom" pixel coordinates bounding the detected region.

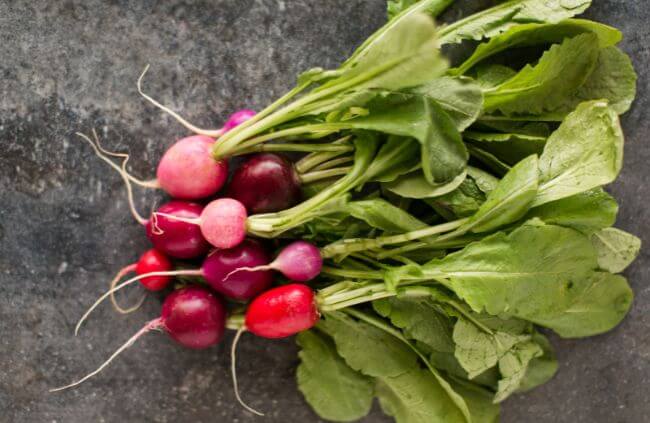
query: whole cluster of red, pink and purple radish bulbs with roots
[{"left": 56, "top": 110, "right": 322, "bottom": 414}]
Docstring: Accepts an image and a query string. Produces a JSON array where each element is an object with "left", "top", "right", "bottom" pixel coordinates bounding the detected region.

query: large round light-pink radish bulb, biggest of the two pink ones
[{"left": 156, "top": 135, "right": 228, "bottom": 200}]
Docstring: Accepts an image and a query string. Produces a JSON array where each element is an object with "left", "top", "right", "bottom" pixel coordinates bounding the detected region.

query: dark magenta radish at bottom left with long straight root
[{"left": 50, "top": 286, "right": 226, "bottom": 392}]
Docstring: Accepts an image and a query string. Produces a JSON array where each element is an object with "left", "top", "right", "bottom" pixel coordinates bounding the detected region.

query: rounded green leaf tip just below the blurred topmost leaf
[{"left": 413, "top": 76, "right": 483, "bottom": 131}]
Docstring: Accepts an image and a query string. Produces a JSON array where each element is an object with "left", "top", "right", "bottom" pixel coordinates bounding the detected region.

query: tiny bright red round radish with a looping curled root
[{"left": 110, "top": 248, "right": 172, "bottom": 314}]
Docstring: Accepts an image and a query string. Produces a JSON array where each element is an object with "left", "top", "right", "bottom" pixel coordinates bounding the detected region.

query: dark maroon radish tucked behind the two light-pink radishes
[{"left": 226, "top": 153, "right": 301, "bottom": 214}]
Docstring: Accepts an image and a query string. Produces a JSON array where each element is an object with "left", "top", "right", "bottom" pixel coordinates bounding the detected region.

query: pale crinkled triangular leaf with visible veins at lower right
[{"left": 454, "top": 318, "right": 530, "bottom": 379}]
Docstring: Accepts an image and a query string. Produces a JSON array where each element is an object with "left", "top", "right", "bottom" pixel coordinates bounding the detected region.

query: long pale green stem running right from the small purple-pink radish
[{"left": 321, "top": 218, "right": 468, "bottom": 258}]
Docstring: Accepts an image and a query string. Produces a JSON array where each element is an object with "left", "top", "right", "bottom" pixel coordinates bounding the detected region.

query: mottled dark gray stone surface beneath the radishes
[{"left": 0, "top": 0, "right": 650, "bottom": 423}]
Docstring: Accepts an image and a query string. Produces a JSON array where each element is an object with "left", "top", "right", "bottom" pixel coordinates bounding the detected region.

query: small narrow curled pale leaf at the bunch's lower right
[{"left": 494, "top": 341, "right": 543, "bottom": 403}]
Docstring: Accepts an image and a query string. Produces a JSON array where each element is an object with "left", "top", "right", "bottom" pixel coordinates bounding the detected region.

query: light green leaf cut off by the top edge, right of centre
[{"left": 440, "top": 0, "right": 591, "bottom": 44}]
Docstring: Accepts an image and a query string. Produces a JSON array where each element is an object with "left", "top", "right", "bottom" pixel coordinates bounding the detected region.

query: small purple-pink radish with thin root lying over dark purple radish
[{"left": 226, "top": 241, "right": 323, "bottom": 282}]
